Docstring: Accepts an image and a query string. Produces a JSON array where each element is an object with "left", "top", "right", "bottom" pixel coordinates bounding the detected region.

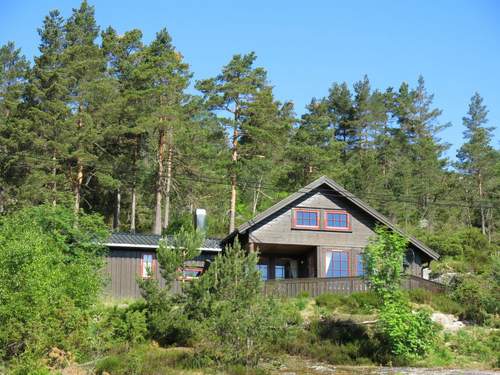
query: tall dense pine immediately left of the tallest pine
[{"left": 26, "top": 10, "right": 70, "bottom": 205}]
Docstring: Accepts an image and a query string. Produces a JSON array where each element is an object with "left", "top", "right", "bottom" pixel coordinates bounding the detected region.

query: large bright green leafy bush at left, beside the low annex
[{"left": 0, "top": 206, "right": 107, "bottom": 368}]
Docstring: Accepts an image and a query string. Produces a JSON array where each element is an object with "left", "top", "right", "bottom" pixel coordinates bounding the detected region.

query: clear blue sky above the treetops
[{"left": 0, "top": 0, "right": 500, "bottom": 158}]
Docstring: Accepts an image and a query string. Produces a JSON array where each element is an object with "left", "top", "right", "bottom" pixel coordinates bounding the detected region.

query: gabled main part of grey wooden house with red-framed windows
[{"left": 222, "top": 176, "right": 439, "bottom": 280}]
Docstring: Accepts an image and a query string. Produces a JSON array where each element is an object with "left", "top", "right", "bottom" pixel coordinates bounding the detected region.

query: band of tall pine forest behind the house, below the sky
[{"left": 0, "top": 1, "right": 500, "bottom": 243}]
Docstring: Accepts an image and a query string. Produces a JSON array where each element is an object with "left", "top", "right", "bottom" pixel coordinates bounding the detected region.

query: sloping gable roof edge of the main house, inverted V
[{"left": 226, "top": 176, "right": 439, "bottom": 259}]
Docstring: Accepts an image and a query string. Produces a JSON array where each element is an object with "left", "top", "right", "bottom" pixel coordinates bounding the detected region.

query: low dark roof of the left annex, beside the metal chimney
[{"left": 105, "top": 232, "right": 221, "bottom": 251}]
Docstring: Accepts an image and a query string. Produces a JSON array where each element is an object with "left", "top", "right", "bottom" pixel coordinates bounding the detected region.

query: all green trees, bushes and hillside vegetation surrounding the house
[{"left": 0, "top": 0, "right": 500, "bottom": 374}]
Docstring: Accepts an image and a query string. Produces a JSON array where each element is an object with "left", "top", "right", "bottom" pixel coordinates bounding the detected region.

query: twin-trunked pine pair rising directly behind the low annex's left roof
[{"left": 102, "top": 27, "right": 147, "bottom": 232}]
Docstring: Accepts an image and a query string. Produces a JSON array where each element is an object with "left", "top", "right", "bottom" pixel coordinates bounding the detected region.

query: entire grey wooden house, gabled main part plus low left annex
[{"left": 106, "top": 176, "right": 439, "bottom": 298}]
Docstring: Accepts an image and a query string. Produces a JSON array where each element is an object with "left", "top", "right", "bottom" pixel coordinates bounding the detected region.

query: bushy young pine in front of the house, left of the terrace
[{"left": 186, "top": 243, "right": 287, "bottom": 366}]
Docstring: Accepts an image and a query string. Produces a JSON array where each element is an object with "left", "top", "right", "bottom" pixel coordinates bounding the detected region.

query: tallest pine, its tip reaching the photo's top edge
[{"left": 63, "top": 0, "right": 110, "bottom": 212}]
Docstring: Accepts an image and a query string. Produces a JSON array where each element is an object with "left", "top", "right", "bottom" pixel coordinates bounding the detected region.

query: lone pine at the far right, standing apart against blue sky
[{"left": 457, "top": 92, "right": 498, "bottom": 234}]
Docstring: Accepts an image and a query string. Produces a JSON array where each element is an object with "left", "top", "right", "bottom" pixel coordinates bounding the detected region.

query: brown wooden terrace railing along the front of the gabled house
[{"left": 263, "top": 275, "right": 445, "bottom": 297}]
